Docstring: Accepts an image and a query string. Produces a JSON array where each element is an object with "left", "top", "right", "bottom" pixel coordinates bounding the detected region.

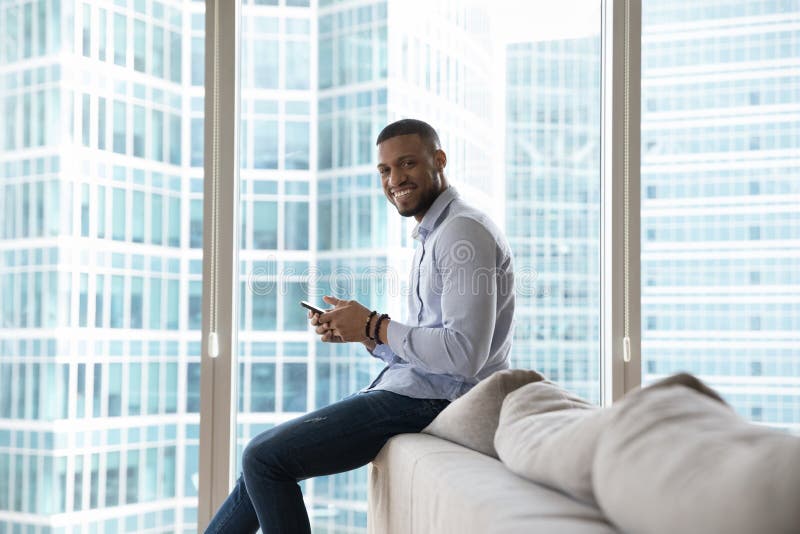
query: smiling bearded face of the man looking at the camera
[{"left": 378, "top": 134, "right": 447, "bottom": 222}]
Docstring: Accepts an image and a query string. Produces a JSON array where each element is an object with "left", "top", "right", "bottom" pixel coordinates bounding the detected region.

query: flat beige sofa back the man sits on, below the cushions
[{"left": 367, "top": 434, "right": 616, "bottom": 534}]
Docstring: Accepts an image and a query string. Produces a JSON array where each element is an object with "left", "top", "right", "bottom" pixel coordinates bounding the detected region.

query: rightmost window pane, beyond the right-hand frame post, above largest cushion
[{"left": 641, "top": 0, "right": 800, "bottom": 433}]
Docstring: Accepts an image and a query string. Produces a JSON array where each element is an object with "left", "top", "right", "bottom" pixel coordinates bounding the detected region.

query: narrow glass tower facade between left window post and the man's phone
[{"left": 235, "top": 0, "right": 317, "bottom": 528}]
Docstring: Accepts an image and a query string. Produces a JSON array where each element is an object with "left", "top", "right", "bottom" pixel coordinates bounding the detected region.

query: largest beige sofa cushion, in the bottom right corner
[{"left": 593, "top": 385, "right": 800, "bottom": 534}]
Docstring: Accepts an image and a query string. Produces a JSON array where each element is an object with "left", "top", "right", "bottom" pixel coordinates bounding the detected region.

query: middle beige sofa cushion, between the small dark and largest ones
[{"left": 494, "top": 382, "right": 609, "bottom": 504}]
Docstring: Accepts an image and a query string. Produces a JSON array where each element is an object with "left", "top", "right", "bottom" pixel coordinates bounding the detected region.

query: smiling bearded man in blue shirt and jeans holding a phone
[{"left": 207, "top": 119, "right": 514, "bottom": 534}]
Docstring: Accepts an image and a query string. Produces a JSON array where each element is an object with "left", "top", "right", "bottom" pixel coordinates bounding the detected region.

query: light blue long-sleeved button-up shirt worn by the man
[{"left": 362, "top": 186, "right": 514, "bottom": 400}]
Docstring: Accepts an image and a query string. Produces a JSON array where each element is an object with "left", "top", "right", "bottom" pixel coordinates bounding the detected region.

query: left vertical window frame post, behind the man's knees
[{"left": 197, "top": 0, "right": 240, "bottom": 530}]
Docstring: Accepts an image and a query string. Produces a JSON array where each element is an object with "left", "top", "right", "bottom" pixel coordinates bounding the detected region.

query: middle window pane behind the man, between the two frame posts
[{"left": 235, "top": 0, "right": 600, "bottom": 532}]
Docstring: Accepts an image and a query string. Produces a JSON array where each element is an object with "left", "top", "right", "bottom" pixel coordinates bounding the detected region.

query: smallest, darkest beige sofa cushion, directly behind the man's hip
[{"left": 423, "top": 369, "right": 544, "bottom": 458}]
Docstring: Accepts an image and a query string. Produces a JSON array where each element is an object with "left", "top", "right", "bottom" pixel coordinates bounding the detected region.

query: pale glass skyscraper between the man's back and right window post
[{"left": 505, "top": 36, "right": 600, "bottom": 403}]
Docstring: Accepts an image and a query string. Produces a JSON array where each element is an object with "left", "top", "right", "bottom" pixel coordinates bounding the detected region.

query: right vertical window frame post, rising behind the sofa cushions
[{"left": 600, "top": 0, "right": 642, "bottom": 405}]
